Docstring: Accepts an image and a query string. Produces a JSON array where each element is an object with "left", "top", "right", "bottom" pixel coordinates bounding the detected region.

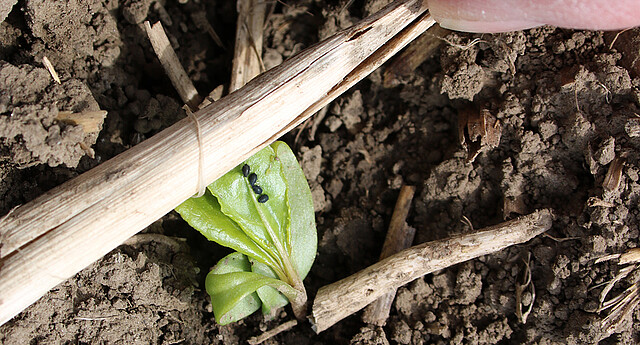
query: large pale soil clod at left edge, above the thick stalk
[{"left": 0, "top": 61, "right": 99, "bottom": 168}]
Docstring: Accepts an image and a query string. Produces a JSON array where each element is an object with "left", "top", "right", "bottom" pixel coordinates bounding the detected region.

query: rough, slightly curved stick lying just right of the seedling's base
[{"left": 311, "top": 209, "right": 553, "bottom": 333}]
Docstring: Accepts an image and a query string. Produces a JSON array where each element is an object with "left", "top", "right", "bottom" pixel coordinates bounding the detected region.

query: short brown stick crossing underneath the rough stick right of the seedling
[{"left": 362, "top": 186, "right": 416, "bottom": 326}]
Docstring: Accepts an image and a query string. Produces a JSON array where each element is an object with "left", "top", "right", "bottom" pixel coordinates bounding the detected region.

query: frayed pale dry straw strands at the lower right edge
[{"left": 596, "top": 248, "right": 640, "bottom": 334}]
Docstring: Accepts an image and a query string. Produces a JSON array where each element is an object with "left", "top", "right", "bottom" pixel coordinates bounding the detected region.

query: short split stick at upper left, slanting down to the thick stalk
[{"left": 144, "top": 21, "right": 202, "bottom": 110}]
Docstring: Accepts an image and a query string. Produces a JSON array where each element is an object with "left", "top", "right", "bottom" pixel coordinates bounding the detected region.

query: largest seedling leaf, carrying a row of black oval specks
[{"left": 209, "top": 142, "right": 317, "bottom": 279}]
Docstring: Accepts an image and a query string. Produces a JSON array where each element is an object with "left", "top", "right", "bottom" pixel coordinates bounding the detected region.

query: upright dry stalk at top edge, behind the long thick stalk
[{"left": 229, "top": 0, "right": 267, "bottom": 92}]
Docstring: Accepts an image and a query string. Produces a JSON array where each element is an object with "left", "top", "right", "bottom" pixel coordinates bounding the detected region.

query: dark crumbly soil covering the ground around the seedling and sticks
[{"left": 0, "top": 0, "right": 640, "bottom": 344}]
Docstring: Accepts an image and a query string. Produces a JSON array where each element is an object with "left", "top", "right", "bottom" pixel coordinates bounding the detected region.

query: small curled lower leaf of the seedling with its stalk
[{"left": 205, "top": 253, "right": 299, "bottom": 325}]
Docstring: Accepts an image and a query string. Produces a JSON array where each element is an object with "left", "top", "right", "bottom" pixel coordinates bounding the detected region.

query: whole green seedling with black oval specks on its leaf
[{"left": 176, "top": 142, "right": 318, "bottom": 325}]
